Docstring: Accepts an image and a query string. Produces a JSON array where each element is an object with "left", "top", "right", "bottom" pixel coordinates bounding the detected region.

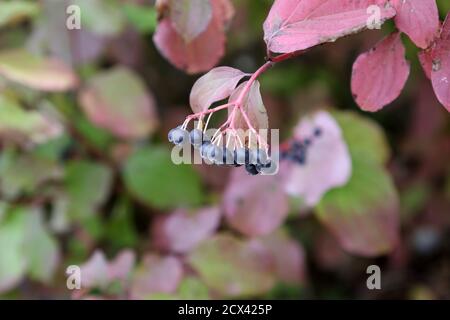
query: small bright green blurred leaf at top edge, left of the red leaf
[{"left": 123, "top": 3, "right": 158, "bottom": 33}]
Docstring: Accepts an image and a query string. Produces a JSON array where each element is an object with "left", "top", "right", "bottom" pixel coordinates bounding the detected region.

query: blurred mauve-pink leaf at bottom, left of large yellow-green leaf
[{"left": 131, "top": 254, "right": 183, "bottom": 299}]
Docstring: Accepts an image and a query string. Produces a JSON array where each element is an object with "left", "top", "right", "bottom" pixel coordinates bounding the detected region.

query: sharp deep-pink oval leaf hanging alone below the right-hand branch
[{"left": 352, "top": 33, "right": 410, "bottom": 112}]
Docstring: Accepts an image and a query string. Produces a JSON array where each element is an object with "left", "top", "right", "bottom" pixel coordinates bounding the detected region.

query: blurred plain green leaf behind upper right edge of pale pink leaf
[{"left": 332, "top": 111, "right": 390, "bottom": 164}]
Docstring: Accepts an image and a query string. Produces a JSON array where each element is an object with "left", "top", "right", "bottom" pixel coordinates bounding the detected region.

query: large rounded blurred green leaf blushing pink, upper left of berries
[{"left": 79, "top": 67, "right": 158, "bottom": 139}]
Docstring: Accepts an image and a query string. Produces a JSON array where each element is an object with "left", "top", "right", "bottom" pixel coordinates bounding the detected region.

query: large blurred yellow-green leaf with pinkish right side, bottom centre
[{"left": 188, "top": 234, "right": 275, "bottom": 297}]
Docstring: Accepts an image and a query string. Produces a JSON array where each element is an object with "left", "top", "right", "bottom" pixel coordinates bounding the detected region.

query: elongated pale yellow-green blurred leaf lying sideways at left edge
[{"left": 0, "top": 49, "right": 78, "bottom": 92}]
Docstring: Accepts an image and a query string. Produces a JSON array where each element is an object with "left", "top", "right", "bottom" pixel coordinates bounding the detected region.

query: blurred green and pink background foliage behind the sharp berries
[{"left": 0, "top": 0, "right": 450, "bottom": 299}]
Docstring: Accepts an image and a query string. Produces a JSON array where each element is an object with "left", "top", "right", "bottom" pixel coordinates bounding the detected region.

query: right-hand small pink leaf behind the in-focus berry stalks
[{"left": 229, "top": 81, "right": 269, "bottom": 134}]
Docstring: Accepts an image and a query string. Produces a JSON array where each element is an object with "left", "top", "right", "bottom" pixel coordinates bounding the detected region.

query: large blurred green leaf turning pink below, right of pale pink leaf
[{"left": 315, "top": 158, "right": 399, "bottom": 256}]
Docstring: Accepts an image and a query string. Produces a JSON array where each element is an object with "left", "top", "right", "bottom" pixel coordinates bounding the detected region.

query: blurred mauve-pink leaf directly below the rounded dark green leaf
[{"left": 153, "top": 207, "right": 220, "bottom": 253}]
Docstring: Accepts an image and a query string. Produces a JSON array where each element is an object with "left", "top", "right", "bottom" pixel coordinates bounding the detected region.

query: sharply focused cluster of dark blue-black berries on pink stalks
[{"left": 168, "top": 127, "right": 276, "bottom": 175}]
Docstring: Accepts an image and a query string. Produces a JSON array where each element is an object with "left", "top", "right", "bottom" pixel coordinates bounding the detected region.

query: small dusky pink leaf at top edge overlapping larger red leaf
[{"left": 170, "top": 0, "right": 212, "bottom": 43}]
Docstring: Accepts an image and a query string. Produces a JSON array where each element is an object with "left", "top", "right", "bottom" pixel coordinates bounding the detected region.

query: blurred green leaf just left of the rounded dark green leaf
[{"left": 64, "top": 160, "right": 112, "bottom": 219}]
